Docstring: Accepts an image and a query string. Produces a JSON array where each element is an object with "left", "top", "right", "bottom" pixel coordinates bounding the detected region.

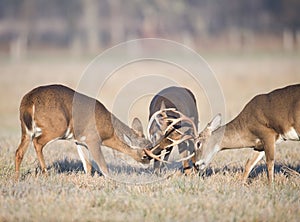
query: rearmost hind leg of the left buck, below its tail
[{"left": 15, "top": 134, "right": 31, "bottom": 180}]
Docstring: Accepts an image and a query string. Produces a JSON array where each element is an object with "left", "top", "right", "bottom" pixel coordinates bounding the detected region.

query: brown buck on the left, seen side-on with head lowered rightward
[{"left": 15, "top": 85, "right": 150, "bottom": 178}]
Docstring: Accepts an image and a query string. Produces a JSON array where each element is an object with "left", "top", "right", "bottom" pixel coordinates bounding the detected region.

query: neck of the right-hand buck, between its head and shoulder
[{"left": 216, "top": 118, "right": 255, "bottom": 150}]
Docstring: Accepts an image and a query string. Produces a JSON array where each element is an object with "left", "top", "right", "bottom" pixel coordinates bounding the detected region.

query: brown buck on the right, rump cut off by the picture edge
[{"left": 195, "top": 84, "right": 300, "bottom": 183}]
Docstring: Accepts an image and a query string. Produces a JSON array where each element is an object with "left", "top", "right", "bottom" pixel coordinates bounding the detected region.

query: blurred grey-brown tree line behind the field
[{"left": 0, "top": 0, "right": 300, "bottom": 57}]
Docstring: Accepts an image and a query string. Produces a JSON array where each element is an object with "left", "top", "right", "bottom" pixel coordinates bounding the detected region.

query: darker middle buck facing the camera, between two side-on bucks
[{"left": 146, "top": 87, "right": 198, "bottom": 173}]
